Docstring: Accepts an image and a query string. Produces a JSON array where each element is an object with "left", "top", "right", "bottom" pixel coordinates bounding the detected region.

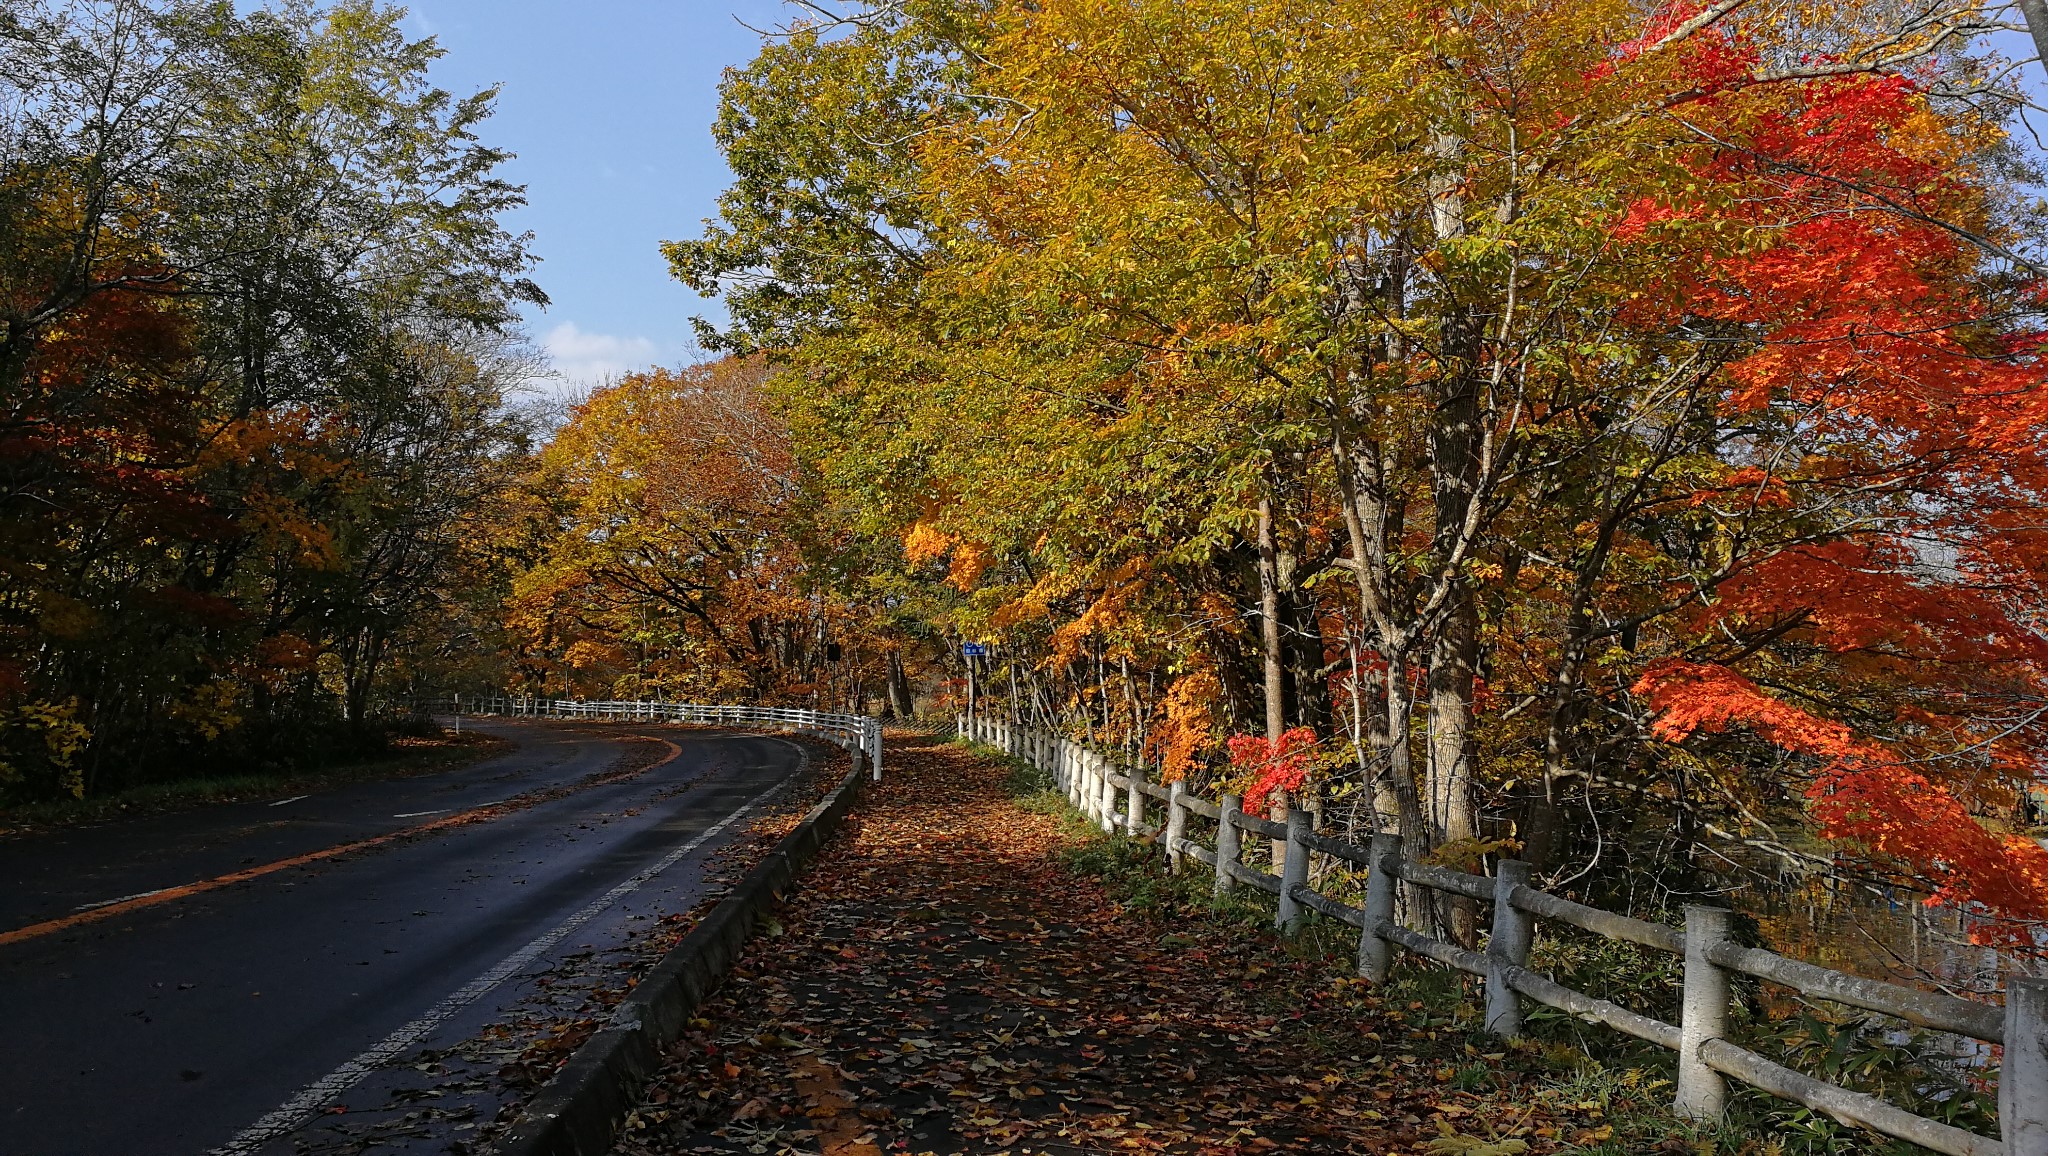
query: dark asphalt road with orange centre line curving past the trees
[{"left": 0, "top": 721, "right": 805, "bottom": 1156}]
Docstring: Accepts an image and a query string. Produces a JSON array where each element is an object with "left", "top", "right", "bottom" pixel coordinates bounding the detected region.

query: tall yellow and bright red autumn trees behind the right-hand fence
[{"left": 668, "top": 0, "right": 2048, "bottom": 938}]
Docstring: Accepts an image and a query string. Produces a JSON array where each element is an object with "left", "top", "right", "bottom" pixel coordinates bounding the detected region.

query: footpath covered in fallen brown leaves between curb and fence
[{"left": 616, "top": 746, "right": 1540, "bottom": 1156}]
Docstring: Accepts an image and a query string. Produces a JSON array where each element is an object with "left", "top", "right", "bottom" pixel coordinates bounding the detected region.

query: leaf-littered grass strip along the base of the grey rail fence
[{"left": 958, "top": 746, "right": 1997, "bottom": 1156}]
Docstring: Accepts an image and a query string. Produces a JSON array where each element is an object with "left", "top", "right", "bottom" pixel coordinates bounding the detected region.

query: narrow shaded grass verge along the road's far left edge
[{"left": 0, "top": 732, "right": 510, "bottom": 836}]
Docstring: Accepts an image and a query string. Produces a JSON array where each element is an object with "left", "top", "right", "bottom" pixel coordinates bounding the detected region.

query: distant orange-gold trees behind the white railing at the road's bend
[{"left": 508, "top": 359, "right": 911, "bottom": 711}]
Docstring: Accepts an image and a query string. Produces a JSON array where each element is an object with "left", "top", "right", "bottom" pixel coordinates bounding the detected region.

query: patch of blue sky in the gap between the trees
[{"left": 406, "top": 0, "right": 793, "bottom": 391}]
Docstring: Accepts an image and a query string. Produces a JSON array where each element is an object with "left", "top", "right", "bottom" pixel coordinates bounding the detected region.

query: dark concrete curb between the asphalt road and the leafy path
[{"left": 487, "top": 765, "right": 864, "bottom": 1156}]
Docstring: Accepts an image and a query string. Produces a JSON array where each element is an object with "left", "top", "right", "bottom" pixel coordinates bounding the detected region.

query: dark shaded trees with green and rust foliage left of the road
[{"left": 0, "top": 0, "right": 545, "bottom": 797}]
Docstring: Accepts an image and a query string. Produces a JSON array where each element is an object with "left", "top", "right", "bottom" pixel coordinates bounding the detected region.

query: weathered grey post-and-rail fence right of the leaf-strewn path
[{"left": 958, "top": 715, "right": 2048, "bottom": 1156}]
